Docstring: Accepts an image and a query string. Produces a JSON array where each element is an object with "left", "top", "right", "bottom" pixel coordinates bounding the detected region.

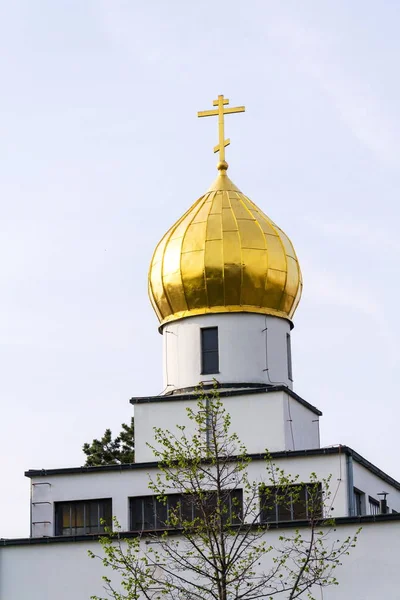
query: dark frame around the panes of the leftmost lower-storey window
[{"left": 54, "top": 498, "right": 112, "bottom": 537}]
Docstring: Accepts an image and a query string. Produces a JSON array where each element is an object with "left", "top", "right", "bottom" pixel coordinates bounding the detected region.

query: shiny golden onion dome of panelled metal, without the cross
[{"left": 149, "top": 162, "right": 302, "bottom": 325}]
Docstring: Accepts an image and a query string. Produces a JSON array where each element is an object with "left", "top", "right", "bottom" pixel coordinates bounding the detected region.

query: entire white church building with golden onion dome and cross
[{"left": 0, "top": 96, "right": 400, "bottom": 600}]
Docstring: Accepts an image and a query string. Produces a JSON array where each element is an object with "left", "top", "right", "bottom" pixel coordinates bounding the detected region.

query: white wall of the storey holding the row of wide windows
[{"left": 28, "top": 447, "right": 400, "bottom": 538}]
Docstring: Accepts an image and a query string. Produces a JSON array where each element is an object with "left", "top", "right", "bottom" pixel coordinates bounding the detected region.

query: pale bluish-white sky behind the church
[{"left": 0, "top": 0, "right": 400, "bottom": 537}]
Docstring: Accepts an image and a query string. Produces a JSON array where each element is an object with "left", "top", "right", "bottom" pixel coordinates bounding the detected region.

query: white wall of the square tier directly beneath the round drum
[{"left": 135, "top": 391, "right": 319, "bottom": 462}]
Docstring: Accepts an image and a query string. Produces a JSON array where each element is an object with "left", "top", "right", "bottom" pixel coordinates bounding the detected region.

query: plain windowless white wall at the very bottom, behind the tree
[{"left": 0, "top": 520, "right": 400, "bottom": 600}]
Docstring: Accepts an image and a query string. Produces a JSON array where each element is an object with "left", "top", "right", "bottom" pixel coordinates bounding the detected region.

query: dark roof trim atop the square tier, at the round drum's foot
[{"left": 129, "top": 383, "right": 322, "bottom": 417}]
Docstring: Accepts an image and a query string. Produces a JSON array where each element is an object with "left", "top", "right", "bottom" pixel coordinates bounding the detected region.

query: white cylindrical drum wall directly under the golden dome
[{"left": 162, "top": 313, "right": 293, "bottom": 391}]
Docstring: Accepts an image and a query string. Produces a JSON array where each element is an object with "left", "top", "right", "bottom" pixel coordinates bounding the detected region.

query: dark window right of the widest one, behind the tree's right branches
[{"left": 260, "top": 483, "right": 323, "bottom": 523}]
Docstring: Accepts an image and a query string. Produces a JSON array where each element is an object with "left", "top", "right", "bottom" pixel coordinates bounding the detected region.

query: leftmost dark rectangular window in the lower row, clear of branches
[{"left": 55, "top": 498, "right": 112, "bottom": 535}]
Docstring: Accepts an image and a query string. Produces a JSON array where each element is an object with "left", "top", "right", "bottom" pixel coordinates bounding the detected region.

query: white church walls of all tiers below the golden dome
[{"left": 0, "top": 162, "right": 400, "bottom": 600}]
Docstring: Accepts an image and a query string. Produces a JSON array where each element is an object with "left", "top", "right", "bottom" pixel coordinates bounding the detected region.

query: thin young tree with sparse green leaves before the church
[{"left": 89, "top": 388, "right": 358, "bottom": 600}]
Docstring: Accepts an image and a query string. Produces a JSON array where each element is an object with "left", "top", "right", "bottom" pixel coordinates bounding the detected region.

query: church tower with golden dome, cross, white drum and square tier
[{"left": 133, "top": 96, "right": 320, "bottom": 460}]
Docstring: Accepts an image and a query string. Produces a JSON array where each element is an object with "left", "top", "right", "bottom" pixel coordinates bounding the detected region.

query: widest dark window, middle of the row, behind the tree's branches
[{"left": 130, "top": 490, "right": 243, "bottom": 531}]
